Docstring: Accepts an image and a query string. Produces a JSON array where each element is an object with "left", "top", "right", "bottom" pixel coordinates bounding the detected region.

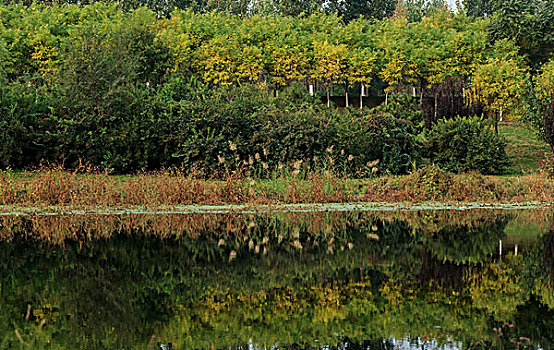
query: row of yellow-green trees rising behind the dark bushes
[{"left": 0, "top": 3, "right": 527, "bottom": 109}]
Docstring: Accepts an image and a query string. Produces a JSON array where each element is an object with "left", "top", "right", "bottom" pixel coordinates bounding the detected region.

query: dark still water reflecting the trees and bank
[{"left": 0, "top": 210, "right": 554, "bottom": 349}]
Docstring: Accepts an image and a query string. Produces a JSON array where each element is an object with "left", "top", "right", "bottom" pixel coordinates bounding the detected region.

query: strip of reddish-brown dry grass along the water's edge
[{"left": 0, "top": 167, "right": 554, "bottom": 208}]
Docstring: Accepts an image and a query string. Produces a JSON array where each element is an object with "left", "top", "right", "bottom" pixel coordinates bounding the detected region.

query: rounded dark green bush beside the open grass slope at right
[{"left": 425, "top": 117, "right": 509, "bottom": 174}]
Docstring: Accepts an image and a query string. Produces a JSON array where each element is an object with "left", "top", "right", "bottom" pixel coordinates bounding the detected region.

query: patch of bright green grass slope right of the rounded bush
[{"left": 498, "top": 122, "right": 550, "bottom": 175}]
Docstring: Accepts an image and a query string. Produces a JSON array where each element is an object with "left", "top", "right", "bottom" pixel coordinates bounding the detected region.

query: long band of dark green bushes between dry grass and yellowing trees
[{"left": 0, "top": 77, "right": 419, "bottom": 176}]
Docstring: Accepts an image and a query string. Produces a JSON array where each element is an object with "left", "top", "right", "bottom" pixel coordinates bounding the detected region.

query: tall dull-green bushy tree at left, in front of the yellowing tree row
[{"left": 55, "top": 10, "right": 172, "bottom": 171}]
